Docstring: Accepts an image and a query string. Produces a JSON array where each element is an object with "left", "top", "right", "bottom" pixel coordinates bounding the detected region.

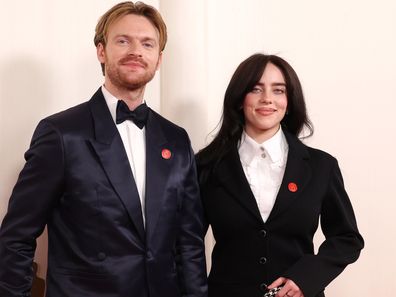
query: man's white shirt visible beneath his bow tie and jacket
[{"left": 102, "top": 86, "right": 146, "bottom": 222}]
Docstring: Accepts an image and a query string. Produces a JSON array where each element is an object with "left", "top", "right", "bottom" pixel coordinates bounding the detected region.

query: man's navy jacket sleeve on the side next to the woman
[{"left": 176, "top": 134, "right": 207, "bottom": 297}]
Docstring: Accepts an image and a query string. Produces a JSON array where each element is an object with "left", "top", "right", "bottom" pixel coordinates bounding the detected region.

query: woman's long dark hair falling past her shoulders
[{"left": 197, "top": 54, "right": 313, "bottom": 170}]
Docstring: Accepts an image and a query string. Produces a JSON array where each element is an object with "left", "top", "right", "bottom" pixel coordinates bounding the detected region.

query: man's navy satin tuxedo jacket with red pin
[{"left": 0, "top": 89, "right": 207, "bottom": 297}]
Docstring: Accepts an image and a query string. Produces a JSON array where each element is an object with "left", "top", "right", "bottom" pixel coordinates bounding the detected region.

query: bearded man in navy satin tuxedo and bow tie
[{"left": 0, "top": 2, "right": 207, "bottom": 297}]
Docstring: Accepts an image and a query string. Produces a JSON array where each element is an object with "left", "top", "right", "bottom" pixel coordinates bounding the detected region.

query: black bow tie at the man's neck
[{"left": 116, "top": 100, "right": 149, "bottom": 129}]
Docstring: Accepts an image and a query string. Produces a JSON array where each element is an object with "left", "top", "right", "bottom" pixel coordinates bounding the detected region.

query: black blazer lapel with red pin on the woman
[{"left": 267, "top": 130, "right": 312, "bottom": 222}]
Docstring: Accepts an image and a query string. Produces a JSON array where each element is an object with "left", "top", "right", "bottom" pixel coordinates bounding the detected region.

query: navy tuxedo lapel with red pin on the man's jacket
[{"left": 145, "top": 110, "right": 172, "bottom": 241}]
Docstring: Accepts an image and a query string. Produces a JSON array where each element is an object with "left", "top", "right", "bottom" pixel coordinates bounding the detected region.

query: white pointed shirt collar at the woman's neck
[{"left": 238, "top": 128, "right": 289, "bottom": 165}]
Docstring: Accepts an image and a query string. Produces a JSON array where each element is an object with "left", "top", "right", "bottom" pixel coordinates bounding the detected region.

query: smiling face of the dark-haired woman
[{"left": 243, "top": 63, "right": 287, "bottom": 143}]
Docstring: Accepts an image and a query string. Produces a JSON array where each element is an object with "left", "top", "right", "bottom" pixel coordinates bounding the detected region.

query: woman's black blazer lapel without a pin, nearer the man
[{"left": 215, "top": 145, "right": 263, "bottom": 221}]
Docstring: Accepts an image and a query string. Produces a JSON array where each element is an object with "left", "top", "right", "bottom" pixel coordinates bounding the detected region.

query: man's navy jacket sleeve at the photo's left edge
[{"left": 0, "top": 121, "right": 63, "bottom": 297}]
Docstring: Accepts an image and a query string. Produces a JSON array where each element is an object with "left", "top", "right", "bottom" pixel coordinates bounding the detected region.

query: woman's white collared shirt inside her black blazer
[{"left": 238, "top": 128, "right": 289, "bottom": 222}]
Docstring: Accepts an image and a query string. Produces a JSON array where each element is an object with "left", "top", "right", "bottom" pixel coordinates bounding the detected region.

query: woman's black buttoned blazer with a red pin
[{"left": 197, "top": 131, "right": 364, "bottom": 297}]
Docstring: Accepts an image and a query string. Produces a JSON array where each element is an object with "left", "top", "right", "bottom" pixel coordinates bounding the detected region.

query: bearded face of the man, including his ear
[{"left": 97, "top": 14, "right": 162, "bottom": 90}]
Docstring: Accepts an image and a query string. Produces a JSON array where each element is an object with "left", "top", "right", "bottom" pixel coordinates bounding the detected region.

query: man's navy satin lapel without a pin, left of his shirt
[{"left": 89, "top": 89, "right": 145, "bottom": 242}]
